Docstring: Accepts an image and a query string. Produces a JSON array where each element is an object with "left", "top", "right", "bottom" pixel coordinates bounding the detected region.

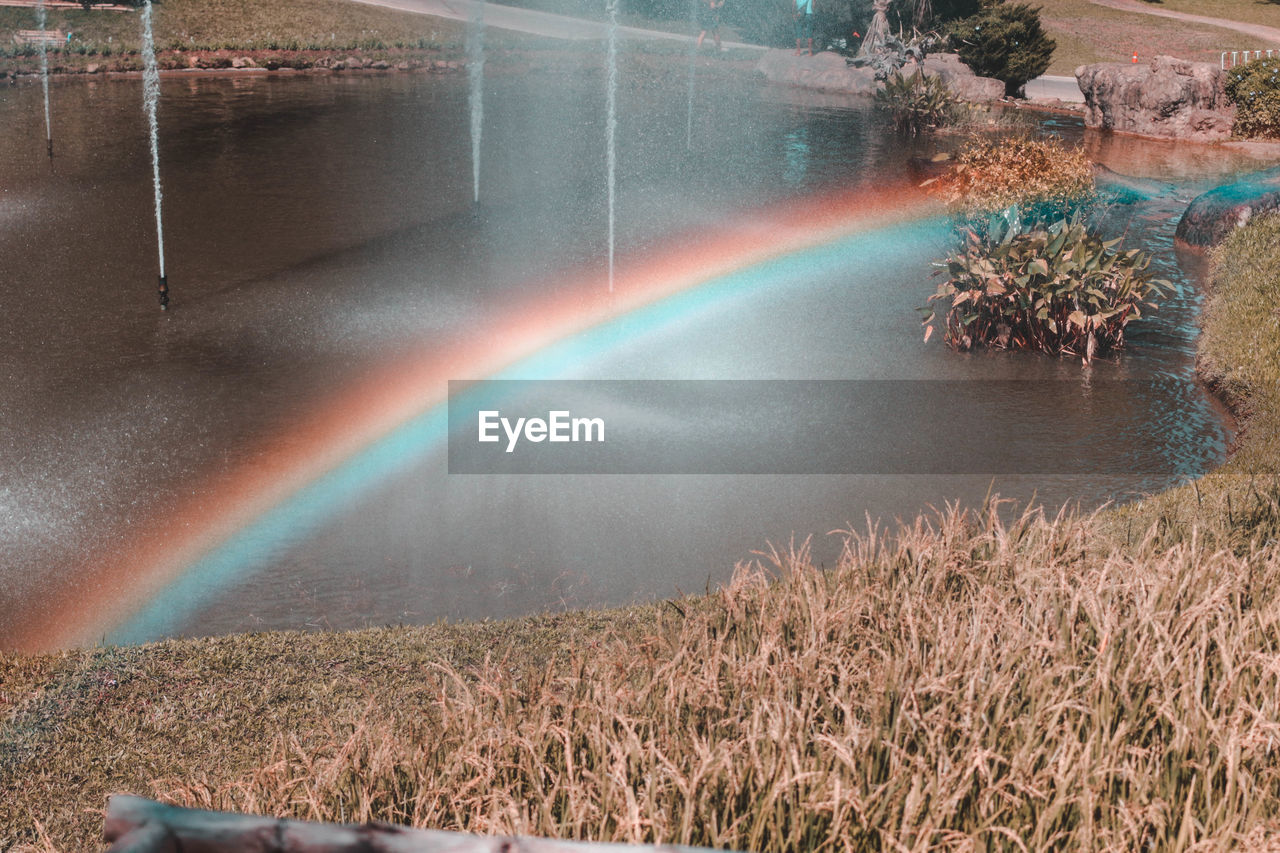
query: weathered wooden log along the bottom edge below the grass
[{"left": 102, "top": 794, "right": 732, "bottom": 853}]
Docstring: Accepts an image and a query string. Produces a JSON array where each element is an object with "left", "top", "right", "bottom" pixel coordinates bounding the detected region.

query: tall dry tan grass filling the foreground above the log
[{"left": 140, "top": 502, "right": 1280, "bottom": 850}]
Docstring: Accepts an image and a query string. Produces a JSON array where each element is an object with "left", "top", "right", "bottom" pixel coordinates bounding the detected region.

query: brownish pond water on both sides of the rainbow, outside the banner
[{"left": 0, "top": 63, "right": 1254, "bottom": 644}]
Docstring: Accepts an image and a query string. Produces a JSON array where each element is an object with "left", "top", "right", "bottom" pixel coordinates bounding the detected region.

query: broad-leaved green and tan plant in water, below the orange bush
[{"left": 922, "top": 215, "right": 1170, "bottom": 362}]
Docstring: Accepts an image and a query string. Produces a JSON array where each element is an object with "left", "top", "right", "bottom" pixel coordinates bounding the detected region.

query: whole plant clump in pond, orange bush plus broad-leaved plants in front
[{"left": 922, "top": 138, "right": 1170, "bottom": 362}]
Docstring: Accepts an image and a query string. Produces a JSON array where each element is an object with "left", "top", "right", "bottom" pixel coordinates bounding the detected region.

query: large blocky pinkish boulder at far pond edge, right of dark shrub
[{"left": 1075, "top": 56, "right": 1235, "bottom": 142}]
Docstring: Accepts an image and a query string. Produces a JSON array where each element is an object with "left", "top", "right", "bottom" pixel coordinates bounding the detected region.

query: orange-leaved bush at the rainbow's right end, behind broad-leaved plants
[{"left": 929, "top": 136, "right": 1097, "bottom": 234}]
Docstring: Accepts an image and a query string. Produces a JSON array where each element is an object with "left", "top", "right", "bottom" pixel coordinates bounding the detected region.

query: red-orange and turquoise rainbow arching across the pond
[{"left": 0, "top": 186, "right": 938, "bottom": 652}]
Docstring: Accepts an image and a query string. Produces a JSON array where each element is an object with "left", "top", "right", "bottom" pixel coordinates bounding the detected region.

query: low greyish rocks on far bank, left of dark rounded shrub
[{"left": 755, "top": 50, "right": 1005, "bottom": 101}]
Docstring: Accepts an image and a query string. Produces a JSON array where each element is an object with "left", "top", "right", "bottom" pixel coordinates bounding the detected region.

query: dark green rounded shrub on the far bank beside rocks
[{"left": 951, "top": 3, "right": 1057, "bottom": 95}]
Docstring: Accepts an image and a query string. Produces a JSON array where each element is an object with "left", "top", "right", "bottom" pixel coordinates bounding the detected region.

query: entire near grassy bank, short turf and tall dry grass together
[{"left": 0, "top": 212, "right": 1280, "bottom": 850}]
